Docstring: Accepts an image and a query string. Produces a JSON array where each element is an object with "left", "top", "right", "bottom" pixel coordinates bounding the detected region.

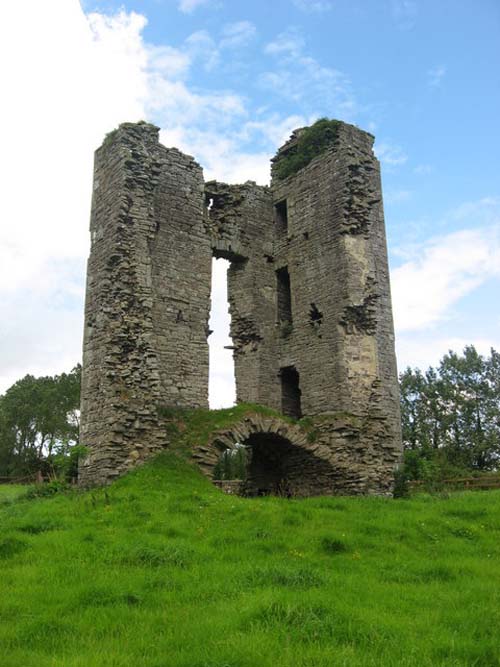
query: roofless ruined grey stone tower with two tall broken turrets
[{"left": 81, "top": 122, "right": 401, "bottom": 492}]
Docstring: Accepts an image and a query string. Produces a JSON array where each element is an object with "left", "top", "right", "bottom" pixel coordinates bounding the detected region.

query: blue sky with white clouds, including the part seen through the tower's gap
[{"left": 0, "top": 0, "right": 500, "bottom": 406}]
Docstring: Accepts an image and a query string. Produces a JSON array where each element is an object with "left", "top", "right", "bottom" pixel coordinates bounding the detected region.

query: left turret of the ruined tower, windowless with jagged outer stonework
[{"left": 80, "top": 123, "right": 211, "bottom": 484}]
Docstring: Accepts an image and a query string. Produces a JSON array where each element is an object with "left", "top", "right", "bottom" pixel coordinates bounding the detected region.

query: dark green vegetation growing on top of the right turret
[{"left": 273, "top": 118, "right": 340, "bottom": 180}]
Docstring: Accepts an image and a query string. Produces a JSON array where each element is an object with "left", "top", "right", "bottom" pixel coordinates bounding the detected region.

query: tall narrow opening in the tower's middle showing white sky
[{"left": 207, "top": 259, "right": 236, "bottom": 410}]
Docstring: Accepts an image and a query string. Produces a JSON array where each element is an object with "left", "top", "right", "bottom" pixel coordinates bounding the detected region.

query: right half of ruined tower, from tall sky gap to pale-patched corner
[{"left": 199, "top": 123, "right": 401, "bottom": 493}]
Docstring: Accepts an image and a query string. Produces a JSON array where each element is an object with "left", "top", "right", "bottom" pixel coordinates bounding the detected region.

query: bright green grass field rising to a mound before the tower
[{"left": 0, "top": 453, "right": 500, "bottom": 667}]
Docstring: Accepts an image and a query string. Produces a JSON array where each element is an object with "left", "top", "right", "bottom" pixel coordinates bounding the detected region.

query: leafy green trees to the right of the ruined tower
[{"left": 400, "top": 345, "right": 500, "bottom": 478}]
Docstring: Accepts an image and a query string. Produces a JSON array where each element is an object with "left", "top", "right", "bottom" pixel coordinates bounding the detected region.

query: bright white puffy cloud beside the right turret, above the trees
[{"left": 391, "top": 226, "right": 500, "bottom": 333}]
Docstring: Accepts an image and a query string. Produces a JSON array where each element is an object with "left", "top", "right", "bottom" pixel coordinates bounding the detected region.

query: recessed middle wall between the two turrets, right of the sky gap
[{"left": 205, "top": 181, "right": 279, "bottom": 405}]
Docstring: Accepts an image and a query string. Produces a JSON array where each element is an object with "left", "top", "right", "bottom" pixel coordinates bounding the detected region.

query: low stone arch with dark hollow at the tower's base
[{"left": 192, "top": 414, "right": 338, "bottom": 496}]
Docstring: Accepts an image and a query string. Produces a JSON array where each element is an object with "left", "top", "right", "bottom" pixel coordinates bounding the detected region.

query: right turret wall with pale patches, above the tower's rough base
[{"left": 272, "top": 123, "right": 400, "bottom": 448}]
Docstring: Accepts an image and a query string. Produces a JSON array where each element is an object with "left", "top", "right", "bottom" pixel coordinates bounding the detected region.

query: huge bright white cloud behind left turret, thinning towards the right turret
[{"left": 0, "top": 0, "right": 288, "bottom": 392}]
